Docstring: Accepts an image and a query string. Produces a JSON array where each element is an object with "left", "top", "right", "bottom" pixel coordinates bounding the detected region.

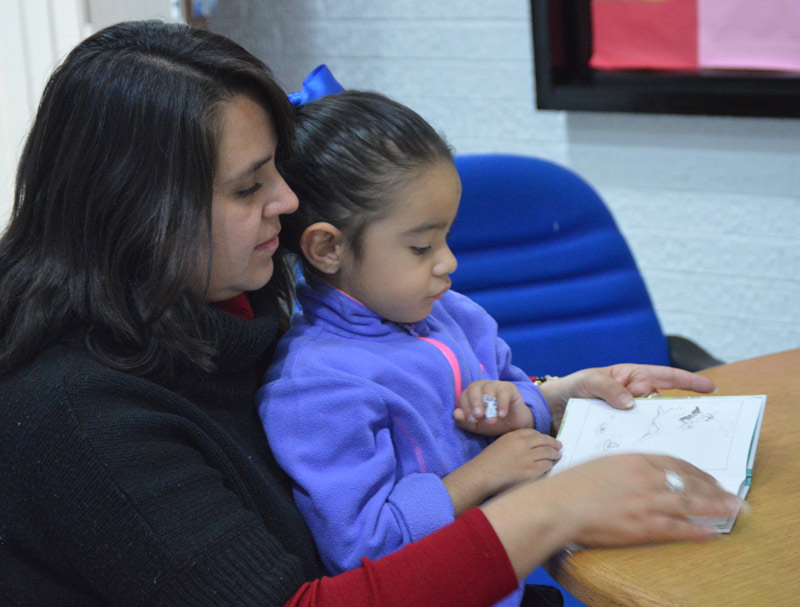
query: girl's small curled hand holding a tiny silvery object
[{"left": 453, "top": 380, "right": 533, "bottom": 436}]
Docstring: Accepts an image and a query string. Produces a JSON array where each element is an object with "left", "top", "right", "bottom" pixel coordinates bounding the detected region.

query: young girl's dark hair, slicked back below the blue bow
[{"left": 280, "top": 90, "right": 453, "bottom": 272}]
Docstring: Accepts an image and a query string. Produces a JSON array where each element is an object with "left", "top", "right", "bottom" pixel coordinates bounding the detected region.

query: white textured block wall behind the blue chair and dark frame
[{"left": 209, "top": 0, "right": 800, "bottom": 361}]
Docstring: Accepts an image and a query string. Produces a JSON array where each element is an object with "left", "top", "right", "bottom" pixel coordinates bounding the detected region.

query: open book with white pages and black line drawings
[{"left": 550, "top": 395, "right": 767, "bottom": 533}]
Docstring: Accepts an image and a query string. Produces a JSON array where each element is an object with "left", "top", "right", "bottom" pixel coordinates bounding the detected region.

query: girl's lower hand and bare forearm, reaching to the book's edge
[{"left": 442, "top": 428, "right": 561, "bottom": 516}]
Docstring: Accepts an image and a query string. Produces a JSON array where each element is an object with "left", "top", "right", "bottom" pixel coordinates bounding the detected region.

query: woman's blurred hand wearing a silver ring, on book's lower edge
[{"left": 482, "top": 454, "right": 743, "bottom": 579}]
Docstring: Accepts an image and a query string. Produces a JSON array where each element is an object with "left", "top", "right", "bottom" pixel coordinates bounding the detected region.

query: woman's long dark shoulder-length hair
[{"left": 0, "top": 21, "right": 293, "bottom": 380}]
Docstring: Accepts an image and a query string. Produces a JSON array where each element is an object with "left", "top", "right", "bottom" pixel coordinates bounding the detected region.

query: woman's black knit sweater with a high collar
[{"left": 0, "top": 315, "right": 322, "bottom": 606}]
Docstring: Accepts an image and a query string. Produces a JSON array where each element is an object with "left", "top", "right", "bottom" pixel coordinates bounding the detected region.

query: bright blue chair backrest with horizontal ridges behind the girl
[{"left": 450, "top": 154, "right": 669, "bottom": 375}]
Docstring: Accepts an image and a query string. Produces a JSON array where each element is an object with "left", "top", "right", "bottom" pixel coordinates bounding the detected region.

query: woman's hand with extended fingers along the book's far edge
[{"left": 540, "top": 363, "right": 716, "bottom": 433}]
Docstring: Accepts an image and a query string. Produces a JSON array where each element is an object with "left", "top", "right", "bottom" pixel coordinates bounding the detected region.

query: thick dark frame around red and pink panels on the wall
[{"left": 531, "top": 0, "right": 800, "bottom": 118}]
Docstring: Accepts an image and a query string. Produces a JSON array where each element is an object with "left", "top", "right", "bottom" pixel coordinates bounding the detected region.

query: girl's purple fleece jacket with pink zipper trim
[{"left": 257, "top": 279, "right": 550, "bottom": 574}]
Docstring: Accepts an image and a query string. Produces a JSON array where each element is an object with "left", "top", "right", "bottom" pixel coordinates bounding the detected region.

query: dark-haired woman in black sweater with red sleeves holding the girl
[{"left": 0, "top": 22, "right": 738, "bottom": 605}]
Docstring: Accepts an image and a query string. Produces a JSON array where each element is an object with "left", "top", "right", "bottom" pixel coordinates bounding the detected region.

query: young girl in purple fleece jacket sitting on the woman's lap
[{"left": 258, "top": 91, "right": 560, "bottom": 604}]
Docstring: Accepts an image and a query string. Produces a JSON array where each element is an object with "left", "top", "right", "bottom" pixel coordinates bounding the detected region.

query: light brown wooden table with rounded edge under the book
[{"left": 548, "top": 349, "right": 800, "bottom": 607}]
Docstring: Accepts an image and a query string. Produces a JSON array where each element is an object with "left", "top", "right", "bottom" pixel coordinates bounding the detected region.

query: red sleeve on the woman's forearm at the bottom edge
[{"left": 286, "top": 508, "right": 517, "bottom": 607}]
